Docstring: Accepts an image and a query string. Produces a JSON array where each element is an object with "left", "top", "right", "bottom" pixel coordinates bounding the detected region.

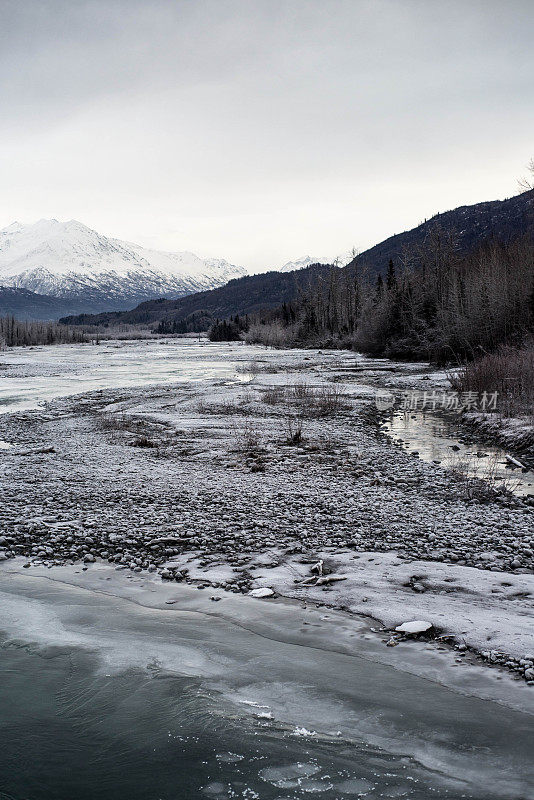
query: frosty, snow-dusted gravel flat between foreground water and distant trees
[{"left": 0, "top": 342, "right": 534, "bottom": 691}]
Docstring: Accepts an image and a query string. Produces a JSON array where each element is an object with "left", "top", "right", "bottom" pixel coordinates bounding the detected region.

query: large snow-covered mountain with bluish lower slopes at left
[{"left": 0, "top": 219, "right": 246, "bottom": 312}]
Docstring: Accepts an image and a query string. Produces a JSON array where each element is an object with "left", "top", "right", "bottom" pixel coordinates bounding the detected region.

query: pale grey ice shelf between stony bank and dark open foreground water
[{"left": 0, "top": 564, "right": 534, "bottom": 800}]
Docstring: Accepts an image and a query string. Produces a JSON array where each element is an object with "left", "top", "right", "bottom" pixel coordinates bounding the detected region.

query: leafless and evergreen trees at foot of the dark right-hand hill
[{"left": 247, "top": 225, "right": 534, "bottom": 363}]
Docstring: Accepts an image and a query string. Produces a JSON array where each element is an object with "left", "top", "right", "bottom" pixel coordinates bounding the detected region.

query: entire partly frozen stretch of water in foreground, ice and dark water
[{"left": 0, "top": 566, "right": 534, "bottom": 800}]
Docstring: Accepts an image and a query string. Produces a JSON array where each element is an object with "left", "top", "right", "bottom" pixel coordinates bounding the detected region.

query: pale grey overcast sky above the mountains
[{"left": 0, "top": 0, "right": 534, "bottom": 269}]
